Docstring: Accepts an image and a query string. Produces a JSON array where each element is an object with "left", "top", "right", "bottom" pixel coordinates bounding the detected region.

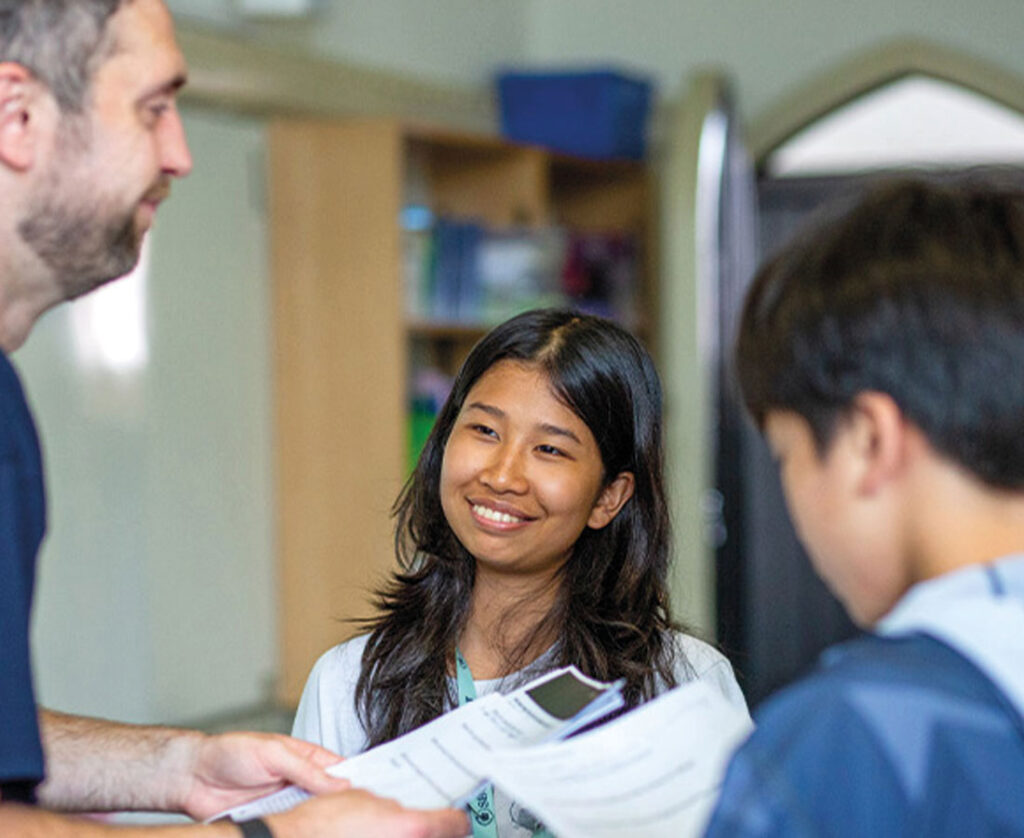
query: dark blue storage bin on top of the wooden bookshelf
[{"left": 498, "top": 70, "right": 651, "bottom": 160}]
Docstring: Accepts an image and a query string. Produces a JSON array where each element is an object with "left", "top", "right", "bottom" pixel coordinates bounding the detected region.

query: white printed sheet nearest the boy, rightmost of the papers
[{"left": 473, "top": 682, "right": 753, "bottom": 838}]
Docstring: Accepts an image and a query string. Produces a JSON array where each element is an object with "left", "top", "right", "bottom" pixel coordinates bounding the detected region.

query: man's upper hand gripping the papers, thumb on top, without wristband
[{"left": 173, "top": 734, "right": 348, "bottom": 820}]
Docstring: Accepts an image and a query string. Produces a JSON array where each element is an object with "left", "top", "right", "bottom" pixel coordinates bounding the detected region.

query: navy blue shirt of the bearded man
[{"left": 0, "top": 352, "right": 46, "bottom": 796}]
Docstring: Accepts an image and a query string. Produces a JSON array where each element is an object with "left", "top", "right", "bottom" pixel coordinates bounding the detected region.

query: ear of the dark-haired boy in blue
[{"left": 849, "top": 391, "right": 909, "bottom": 494}]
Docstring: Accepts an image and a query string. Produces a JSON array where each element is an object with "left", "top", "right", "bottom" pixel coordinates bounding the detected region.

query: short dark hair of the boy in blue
[{"left": 736, "top": 179, "right": 1024, "bottom": 490}]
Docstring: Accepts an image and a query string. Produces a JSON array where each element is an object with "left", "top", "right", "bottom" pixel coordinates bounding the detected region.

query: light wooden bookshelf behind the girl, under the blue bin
[{"left": 268, "top": 119, "right": 654, "bottom": 705}]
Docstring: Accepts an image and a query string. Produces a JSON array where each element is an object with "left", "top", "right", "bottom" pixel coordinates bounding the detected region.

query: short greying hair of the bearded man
[{"left": 0, "top": 0, "right": 131, "bottom": 113}]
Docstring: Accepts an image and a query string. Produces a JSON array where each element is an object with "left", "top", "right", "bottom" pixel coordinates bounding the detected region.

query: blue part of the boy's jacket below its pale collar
[{"left": 707, "top": 634, "right": 1024, "bottom": 838}]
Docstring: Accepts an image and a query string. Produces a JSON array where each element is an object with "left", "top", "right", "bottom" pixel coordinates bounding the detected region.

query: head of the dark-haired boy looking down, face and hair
[{"left": 736, "top": 180, "right": 1024, "bottom": 623}]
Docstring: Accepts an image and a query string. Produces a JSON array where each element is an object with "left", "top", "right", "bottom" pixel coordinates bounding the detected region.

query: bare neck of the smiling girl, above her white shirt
[{"left": 459, "top": 564, "right": 559, "bottom": 679}]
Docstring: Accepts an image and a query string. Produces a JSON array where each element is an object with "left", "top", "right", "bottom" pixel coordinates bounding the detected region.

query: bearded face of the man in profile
[{"left": 18, "top": 0, "right": 191, "bottom": 299}]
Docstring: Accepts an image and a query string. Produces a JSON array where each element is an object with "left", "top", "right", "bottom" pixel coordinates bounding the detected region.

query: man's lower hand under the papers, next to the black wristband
[{"left": 265, "top": 789, "right": 469, "bottom": 838}]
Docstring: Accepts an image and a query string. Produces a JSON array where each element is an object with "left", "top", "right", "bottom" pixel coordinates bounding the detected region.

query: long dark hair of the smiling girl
[{"left": 355, "top": 309, "right": 681, "bottom": 746}]
